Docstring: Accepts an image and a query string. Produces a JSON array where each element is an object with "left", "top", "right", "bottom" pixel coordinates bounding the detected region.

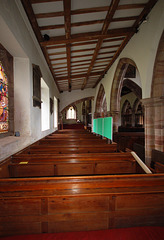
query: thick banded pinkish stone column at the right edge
[{"left": 142, "top": 96, "right": 164, "bottom": 166}]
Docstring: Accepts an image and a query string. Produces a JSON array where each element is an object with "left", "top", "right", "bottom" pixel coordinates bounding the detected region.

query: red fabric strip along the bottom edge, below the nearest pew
[{"left": 0, "top": 227, "right": 164, "bottom": 240}]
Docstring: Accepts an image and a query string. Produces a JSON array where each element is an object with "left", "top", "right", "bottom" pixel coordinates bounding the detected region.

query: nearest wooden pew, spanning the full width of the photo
[{"left": 0, "top": 174, "right": 164, "bottom": 238}]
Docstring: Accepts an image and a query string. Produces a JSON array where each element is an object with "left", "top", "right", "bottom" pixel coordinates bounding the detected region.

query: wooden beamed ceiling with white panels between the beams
[{"left": 21, "top": 0, "right": 158, "bottom": 92}]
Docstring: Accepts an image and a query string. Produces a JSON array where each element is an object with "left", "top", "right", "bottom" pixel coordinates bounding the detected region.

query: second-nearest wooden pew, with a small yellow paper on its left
[{"left": 9, "top": 154, "right": 139, "bottom": 177}]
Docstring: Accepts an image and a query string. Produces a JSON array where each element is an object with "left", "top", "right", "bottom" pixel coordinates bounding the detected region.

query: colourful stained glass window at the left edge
[{"left": 0, "top": 62, "right": 9, "bottom": 133}]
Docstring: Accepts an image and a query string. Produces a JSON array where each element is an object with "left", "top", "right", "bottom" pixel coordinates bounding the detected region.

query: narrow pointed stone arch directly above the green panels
[{"left": 95, "top": 84, "right": 107, "bottom": 117}]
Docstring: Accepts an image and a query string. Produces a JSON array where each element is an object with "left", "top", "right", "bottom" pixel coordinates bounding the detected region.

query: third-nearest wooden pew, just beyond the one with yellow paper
[{"left": 22, "top": 143, "right": 117, "bottom": 154}]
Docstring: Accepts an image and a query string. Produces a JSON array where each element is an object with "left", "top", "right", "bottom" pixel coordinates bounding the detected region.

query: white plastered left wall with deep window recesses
[{"left": 0, "top": 0, "right": 59, "bottom": 161}]
